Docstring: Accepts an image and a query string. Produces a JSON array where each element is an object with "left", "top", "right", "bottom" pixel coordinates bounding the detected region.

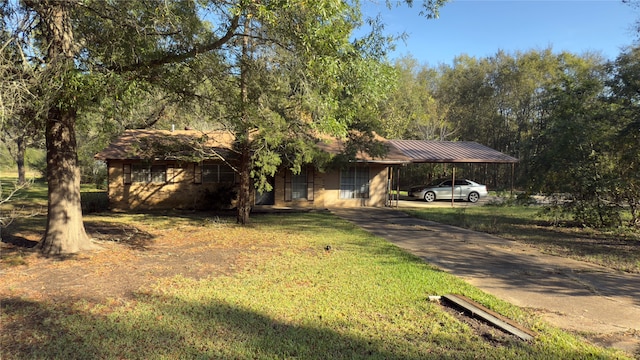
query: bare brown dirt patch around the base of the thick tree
[{"left": 0, "top": 215, "right": 260, "bottom": 303}]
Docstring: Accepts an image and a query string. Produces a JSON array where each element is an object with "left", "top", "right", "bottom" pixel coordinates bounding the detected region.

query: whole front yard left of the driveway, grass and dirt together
[{"left": 0, "top": 207, "right": 625, "bottom": 359}]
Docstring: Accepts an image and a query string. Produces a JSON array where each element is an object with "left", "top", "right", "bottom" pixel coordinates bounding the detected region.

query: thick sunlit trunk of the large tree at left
[{"left": 31, "top": 0, "right": 94, "bottom": 255}]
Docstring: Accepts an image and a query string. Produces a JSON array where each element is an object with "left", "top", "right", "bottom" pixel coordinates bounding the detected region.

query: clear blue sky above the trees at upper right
[{"left": 363, "top": 0, "right": 640, "bottom": 66}]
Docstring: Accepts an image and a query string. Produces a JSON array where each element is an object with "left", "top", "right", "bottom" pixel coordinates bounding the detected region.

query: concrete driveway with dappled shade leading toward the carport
[{"left": 331, "top": 208, "right": 640, "bottom": 356}]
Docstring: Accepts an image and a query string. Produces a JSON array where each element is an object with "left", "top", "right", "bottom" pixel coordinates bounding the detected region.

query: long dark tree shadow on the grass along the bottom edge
[{"left": 0, "top": 296, "right": 600, "bottom": 360}]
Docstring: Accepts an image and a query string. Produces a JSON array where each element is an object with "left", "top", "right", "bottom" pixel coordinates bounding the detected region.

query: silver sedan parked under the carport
[{"left": 409, "top": 179, "right": 488, "bottom": 203}]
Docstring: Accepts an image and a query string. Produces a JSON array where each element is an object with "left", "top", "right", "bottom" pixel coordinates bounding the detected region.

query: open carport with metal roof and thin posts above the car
[{"left": 389, "top": 140, "right": 519, "bottom": 206}]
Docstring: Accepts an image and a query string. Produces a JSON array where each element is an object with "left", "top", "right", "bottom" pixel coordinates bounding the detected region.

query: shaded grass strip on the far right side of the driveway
[{"left": 406, "top": 205, "right": 640, "bottom": 273}]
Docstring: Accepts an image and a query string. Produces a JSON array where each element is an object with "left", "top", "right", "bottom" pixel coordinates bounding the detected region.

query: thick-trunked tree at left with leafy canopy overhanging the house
[{"left": 0, "top": 0, "right": 444, "bottom": 254}]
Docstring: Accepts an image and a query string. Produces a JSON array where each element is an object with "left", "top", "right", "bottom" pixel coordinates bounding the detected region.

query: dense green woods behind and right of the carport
[{"left": 383, "top": 47, "right": 640, "bottom": 226}]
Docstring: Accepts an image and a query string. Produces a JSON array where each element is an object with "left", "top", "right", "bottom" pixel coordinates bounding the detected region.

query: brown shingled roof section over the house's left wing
[{"left": 95, "top": 130, "right": 235, "bottom": 160}]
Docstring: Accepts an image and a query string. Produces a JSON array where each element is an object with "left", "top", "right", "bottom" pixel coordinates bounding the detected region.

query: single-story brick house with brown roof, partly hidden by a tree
[{"left": 95, "top": 130, "right": 410, "bottom": 210}]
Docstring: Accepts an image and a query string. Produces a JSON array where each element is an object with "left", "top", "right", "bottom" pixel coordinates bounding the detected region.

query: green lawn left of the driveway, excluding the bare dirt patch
[{"left": 0, "top": 213, "right": 624, "bottom": 359}]
